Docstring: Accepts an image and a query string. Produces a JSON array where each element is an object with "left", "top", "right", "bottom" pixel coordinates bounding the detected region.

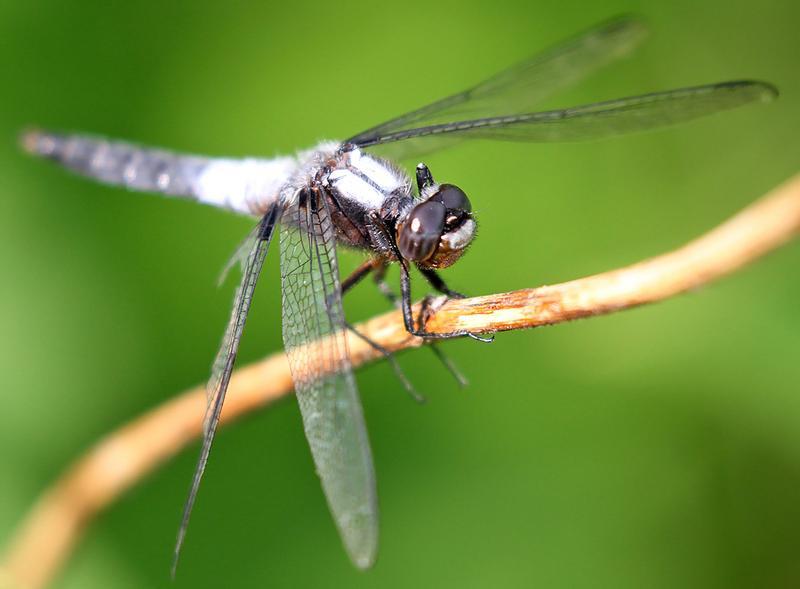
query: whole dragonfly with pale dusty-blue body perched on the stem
[{"left": 22, "top": 17, "right": 777, "bottom": 574}]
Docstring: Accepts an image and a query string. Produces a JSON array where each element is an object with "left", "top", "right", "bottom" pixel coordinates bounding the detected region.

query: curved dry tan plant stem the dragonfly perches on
[{"left": 0, "top": 176, "right": 800, "bottom": 589}]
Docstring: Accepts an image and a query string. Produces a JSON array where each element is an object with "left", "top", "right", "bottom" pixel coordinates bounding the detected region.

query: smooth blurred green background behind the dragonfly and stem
[{"left": 0, "top": 0, "right": 800, "bottom": 589}]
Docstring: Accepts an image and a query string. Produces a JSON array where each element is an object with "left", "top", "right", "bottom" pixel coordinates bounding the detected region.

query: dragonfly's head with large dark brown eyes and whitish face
[{"left": 396, "top": 184, "right": 476, "bottom": 268}]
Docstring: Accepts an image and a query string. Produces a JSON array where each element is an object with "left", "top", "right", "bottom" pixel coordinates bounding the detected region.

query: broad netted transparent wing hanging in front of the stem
[{"left": 281, "top": 191, "right": 378, "bottom": 568}]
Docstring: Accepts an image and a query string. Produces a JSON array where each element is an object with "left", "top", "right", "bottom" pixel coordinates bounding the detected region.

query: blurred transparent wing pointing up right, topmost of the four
[{"left": 348, "top": 17, "right": 647, "bottom": 157}]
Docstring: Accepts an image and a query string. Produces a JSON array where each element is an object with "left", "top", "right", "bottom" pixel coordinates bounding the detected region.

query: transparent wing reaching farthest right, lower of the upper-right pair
[{"left": 348, "top": 81, "right": 778, "bottom": 157}]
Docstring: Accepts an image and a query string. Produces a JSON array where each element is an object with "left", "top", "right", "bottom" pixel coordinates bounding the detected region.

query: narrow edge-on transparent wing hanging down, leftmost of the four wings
[{"left": 172, "top": 205, "right": 278, "bottom": 576}]
